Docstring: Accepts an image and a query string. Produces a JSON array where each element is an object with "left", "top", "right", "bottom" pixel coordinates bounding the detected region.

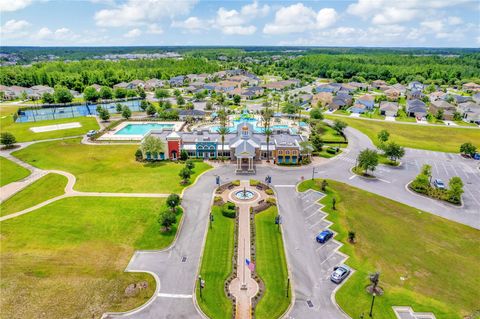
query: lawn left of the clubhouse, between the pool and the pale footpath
[{"left": 14, "top": 139, "right": 210, "bottom": 193}]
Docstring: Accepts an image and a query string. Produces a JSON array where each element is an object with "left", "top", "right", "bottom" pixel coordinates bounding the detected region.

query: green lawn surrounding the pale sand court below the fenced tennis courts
[{"left": 0, "top": 116, "right": 99, "bottom": 142}]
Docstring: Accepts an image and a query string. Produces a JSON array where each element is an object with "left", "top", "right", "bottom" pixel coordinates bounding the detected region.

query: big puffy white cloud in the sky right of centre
[{"left": 263, "top": 3, "right": 338, "bottom": 34}]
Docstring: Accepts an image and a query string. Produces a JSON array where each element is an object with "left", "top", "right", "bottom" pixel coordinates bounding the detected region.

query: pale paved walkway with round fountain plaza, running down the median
[{"left": 225, "top": 180, "right": 266, "bottom": 319}]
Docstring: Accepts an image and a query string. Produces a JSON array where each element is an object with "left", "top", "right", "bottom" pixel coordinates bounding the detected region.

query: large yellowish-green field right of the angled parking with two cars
[{"left": 299, "top": 180, "right": 480, "bottom": 319}]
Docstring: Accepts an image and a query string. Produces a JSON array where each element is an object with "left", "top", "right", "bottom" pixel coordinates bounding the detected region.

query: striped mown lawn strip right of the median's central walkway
[{"left": 255, "top": 206, "right": 292, "bottom": 319}]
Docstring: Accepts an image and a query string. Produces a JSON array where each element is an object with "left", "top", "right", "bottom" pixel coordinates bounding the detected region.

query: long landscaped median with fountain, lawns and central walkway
[{"left": 196, "top": 180, "right": 291, "bottom": 319}]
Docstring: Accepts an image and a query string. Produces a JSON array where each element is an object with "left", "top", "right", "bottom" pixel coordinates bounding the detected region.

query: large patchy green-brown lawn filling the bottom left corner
[{"left": 0, "top": 197, "right": 181, "bottom": 319}]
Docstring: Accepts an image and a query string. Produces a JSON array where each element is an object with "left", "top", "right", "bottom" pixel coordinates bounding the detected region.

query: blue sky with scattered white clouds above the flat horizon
[{"left": 0, "top": 0, "right": 480, "bottom": 48}]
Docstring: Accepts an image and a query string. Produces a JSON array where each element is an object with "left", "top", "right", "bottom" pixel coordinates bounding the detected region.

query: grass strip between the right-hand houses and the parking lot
[{"left": 327, "top": 115, "right": 480, "bottom": 153}]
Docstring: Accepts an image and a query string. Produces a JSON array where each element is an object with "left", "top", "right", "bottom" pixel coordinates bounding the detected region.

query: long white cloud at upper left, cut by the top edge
[{"left": 95, "top": 0, "right": 197, "bottom": 27}]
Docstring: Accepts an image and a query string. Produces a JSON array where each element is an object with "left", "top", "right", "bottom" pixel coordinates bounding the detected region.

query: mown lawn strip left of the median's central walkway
[{"left": 196, "top": 206, "right": 235, "bottom": 319}]
